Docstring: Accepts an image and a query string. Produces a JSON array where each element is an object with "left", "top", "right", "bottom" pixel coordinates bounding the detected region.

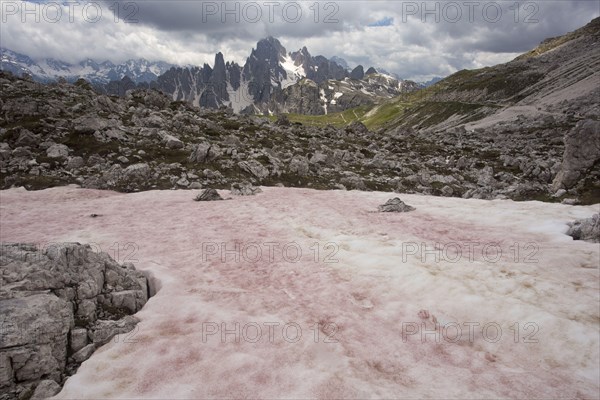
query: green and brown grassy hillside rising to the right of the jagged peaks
[{"left": 278, "top": 18, "right": 600, "bottom": 130}]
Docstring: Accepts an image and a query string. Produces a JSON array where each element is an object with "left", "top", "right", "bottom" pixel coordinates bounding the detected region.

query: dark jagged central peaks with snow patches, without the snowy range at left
[{"left": 150, "top": 37, "right": 420, "bottom": 115}]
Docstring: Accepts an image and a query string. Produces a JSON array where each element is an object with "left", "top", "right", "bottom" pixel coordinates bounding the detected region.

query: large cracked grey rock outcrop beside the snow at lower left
[{"left": 0, "top": 243, "right": 148, "bottom": 399}]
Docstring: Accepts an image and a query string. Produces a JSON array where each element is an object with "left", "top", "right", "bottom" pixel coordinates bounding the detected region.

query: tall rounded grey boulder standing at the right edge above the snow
[{"left": 552, "top": 119, "right": 600, "bottom": 191}]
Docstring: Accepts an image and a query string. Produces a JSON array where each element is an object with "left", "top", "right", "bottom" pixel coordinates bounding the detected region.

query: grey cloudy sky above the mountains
[{"left": 0, "top": 0, "right": 600, "bottom": 81}]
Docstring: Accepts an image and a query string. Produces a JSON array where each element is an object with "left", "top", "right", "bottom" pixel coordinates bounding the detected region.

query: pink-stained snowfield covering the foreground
[{"left": 0, "top": 186, "right": 600, "bottom": 399}]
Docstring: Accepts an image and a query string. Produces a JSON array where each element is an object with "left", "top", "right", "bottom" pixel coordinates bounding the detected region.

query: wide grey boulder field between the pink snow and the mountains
[{"left": 0, "top": 66, "right": 598, "bottom": 203}]
